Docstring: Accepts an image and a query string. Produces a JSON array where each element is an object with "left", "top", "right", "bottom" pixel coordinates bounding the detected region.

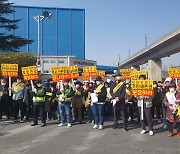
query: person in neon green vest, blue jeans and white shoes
[{"left": 57, "top": 80, "right": 74, "bottom": 127}]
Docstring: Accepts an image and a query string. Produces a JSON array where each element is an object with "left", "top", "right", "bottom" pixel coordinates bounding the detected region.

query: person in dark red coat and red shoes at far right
[{"left": 164, "top": 83, "right": 180, "bottom": 138}]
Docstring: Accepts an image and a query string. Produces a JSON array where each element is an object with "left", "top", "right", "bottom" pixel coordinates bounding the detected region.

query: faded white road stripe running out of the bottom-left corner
[{"left": 3, "top": 127, "right": 69, "bottom": 154}]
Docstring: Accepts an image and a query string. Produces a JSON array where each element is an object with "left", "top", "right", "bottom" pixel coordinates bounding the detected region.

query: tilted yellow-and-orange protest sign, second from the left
[{"left": 21, "top": 66, "right": 38, "bottom": 81}]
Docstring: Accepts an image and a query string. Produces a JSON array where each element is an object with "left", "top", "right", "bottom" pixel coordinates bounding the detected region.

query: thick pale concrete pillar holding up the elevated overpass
[{"left": 148, "top": 59, "right": 162, "bottom": 81}]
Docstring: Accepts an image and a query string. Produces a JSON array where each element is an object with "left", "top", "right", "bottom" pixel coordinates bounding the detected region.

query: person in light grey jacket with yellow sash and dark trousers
[{"left": 12, "top": 77, "right": 27, "bottom": 123}]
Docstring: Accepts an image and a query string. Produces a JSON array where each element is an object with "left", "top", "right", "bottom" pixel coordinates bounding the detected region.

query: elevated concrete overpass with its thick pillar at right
[{"left": 120, "top": 27, "right": 180, "bottom": 81}]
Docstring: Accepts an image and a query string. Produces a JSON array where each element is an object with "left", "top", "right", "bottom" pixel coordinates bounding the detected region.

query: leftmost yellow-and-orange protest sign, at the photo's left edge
[{"left": 1, "top": 64, "right": 18, "bottom": 77}]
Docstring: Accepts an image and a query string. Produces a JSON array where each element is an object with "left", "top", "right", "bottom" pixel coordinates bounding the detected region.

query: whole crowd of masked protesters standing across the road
[{"left": 0, "top": 73, "right": 180, "bottom": 138}]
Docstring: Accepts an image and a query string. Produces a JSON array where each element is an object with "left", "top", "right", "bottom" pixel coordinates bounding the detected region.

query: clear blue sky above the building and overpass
[{"left": 9, "top": 0, "right": 180, "bottom": 68}]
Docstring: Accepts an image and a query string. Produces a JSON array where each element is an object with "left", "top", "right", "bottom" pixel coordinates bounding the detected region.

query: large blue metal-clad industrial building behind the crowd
[{"left": 0, "top": 6, "right": 85, "bottom": 59}]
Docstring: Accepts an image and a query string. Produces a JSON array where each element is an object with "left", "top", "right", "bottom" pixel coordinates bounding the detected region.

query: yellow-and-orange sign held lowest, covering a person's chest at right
[{"left": 131, "top": 80, "right": 154, "bottom": 96}]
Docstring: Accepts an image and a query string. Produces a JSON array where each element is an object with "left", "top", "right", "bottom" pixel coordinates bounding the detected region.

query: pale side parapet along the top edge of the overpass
[{"left": 120, "top": 26, "right": 180, "bottom": 66}]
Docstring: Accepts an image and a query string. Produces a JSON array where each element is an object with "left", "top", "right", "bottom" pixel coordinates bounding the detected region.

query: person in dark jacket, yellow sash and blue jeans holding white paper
[{"left": 91, "top": 76, "right": 107, "bottom": 130}]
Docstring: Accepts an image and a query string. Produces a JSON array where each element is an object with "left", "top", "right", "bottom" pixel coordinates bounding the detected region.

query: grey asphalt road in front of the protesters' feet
[{"left": 0, "top": 121, "right": 180, "bottom": 154}]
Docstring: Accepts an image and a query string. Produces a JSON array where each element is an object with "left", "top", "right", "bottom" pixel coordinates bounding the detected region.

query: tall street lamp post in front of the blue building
[{"left": 33, "top": 11, "right": 52, "bottom": 71}]
